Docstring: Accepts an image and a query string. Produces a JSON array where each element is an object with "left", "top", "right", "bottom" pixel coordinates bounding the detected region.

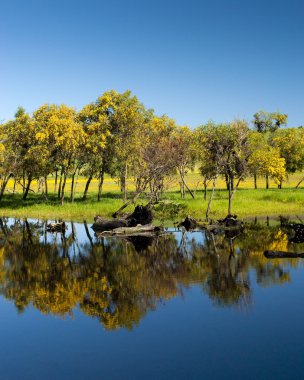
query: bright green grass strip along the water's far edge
[{"left": 0, "top": 188, "right": 304, "bottom": 221}]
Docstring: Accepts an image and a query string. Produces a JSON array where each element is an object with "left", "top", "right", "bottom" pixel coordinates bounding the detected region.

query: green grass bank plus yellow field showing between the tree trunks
[{"left": 0, "top": 173, "right": 304, "bottom": 221}]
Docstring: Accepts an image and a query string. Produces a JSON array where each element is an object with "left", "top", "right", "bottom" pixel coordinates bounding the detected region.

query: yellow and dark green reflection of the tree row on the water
[{"left": 0, "top": 219, "right": 298, "bottom": 329}]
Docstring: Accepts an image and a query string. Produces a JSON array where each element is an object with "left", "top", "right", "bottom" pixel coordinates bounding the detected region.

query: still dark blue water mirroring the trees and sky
[{"left": 0, "top": 218, "right": 304, "bottom": 380}]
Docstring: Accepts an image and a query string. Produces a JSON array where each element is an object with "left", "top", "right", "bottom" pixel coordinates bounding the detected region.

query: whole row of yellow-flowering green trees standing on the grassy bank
[{"left": 0, "top": 90, "right": 304, "bottom": 214}]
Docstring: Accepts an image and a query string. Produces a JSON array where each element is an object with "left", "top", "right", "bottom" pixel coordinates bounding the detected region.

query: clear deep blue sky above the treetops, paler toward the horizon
[{"left": 0, "top": 0, "right": 304, "bottom": 127}]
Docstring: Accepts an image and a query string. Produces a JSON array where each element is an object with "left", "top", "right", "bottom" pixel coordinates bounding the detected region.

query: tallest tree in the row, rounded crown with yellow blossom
[{"left": 79, "top": 91, "right": 146, "bottom": 201}]
